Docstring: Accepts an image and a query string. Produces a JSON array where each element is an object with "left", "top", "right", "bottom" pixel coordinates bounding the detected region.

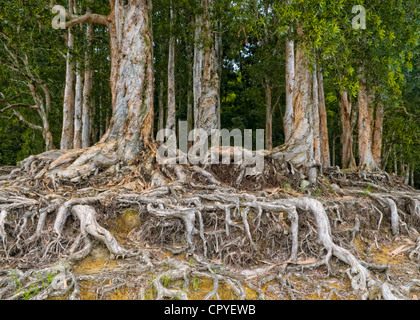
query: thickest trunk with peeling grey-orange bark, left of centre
[{"left": 101, "top": 0, "right": 154, "bottom": 163}]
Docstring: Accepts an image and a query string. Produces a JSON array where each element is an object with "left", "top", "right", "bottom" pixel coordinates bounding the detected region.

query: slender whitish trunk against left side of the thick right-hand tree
[{"left": 283, "top": 40, "right": 295, "bottom": 142}]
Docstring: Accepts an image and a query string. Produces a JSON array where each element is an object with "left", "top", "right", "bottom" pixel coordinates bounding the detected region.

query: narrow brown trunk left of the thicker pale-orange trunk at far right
[{"left": 340, "top": 90, "right": 356, "bottom": 169}]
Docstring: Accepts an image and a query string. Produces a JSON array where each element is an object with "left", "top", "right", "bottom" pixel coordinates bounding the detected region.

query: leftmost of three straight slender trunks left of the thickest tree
[{"left": 60, "top": 0, "right": 75, "bottom": 150}]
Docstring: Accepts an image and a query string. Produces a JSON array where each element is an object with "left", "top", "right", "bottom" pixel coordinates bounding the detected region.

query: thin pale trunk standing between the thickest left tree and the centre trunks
[{"left": 166, "top": 4, "right": 176, "bottom": 131}]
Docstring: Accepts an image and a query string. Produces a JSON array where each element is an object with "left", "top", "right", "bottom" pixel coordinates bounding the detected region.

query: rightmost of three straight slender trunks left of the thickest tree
[{"left": 82, "top": 17, "right": 93, "bottom": 149}]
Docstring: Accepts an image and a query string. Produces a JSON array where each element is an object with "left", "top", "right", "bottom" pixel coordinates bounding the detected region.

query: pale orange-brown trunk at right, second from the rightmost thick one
[{"left": 359, "top": 79, "right": 376, "bottom": 171}]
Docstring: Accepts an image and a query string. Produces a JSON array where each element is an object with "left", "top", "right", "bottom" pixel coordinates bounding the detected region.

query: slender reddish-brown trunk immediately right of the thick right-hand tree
[{"left": 318, "top": 70, "right": 331, "bottom": 167}]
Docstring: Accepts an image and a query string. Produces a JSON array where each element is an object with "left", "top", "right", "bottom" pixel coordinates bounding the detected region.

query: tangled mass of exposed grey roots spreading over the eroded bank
[{"left": 0, "top": 150, "right": 420, "bottom": 299}]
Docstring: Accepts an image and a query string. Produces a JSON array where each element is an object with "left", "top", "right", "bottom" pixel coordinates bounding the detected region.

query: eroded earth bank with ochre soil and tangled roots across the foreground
[{"left": 0, "top": 150, "right": 420, "bottom": 300}]
